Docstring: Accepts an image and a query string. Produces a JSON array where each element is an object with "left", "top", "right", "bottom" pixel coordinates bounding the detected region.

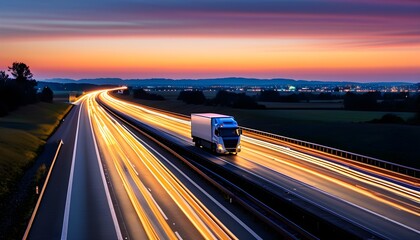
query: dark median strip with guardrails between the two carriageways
[{"left": 98, "top": 97, "right": 379, "bottom": 239}]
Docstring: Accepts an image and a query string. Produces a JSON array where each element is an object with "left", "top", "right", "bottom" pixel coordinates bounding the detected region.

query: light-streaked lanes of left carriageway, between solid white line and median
[{"left": 91, "top": 91, "right": 275, "bottom": 239}]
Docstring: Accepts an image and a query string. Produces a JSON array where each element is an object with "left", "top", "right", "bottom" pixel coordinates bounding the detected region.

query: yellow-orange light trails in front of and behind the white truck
[{"left": 100, "top": 89, "right": 420, "bottom": 216}]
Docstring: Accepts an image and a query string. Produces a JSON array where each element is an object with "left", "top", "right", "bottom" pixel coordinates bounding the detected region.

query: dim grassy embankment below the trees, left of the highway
[{"left": 0, "top": 102, "right": 71, "bottom": 200}]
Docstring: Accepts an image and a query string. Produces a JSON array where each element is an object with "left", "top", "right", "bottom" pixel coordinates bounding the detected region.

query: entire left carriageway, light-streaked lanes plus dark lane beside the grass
[{"left": 29, "top": 92, "right": 275, "bottom": 239}]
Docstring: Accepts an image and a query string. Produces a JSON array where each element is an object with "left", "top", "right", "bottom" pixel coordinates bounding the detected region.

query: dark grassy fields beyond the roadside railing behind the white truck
[{"left": 116, "top": 92, "right": 420, "bottom": 168}]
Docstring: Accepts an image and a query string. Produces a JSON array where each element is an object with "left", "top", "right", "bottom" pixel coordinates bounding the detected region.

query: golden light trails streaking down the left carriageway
[{"left": 87, "top": 91, "right": 236, "bottom": 239}]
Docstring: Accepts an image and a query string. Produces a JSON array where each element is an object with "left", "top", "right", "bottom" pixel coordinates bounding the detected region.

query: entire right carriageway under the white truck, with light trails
[{"left": 100, "top": 93, "right": 420, "bottom": 239}]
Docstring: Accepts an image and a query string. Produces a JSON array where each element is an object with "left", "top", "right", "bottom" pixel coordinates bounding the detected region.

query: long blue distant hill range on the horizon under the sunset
[{"left": 41, "top": 77, "right": 414, "bottom": 87}]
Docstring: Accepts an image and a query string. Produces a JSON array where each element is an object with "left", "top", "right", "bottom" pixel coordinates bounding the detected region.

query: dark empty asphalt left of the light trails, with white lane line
[{"left": 29, "top": 93, "right": 122, "bottom": 239}]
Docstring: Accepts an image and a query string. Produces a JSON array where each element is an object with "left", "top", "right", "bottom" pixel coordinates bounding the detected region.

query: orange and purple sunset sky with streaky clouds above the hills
[{"left": 0, "top": 0, "right": 420, "bottom": 82}]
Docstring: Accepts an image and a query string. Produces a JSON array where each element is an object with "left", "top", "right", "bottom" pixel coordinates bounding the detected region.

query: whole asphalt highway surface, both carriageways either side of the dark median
[{"left": 29, "top": 91, "right": 420, "bottom": 239}]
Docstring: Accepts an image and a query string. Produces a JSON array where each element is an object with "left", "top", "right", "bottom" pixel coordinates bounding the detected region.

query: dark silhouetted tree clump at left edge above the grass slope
[{"left": 0, "top": 62, "right": 54, "bottom": 116}]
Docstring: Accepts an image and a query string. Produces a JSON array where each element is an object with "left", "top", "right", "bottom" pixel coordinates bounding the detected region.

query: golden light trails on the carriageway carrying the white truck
[{"left": 100, "top": 90, "right": 420, "bottom": 232}]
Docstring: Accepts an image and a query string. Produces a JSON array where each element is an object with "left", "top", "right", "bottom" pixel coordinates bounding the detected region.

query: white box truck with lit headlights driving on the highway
[{"left": 191, "top": 113, "right": 242, "bottom": 154}]
